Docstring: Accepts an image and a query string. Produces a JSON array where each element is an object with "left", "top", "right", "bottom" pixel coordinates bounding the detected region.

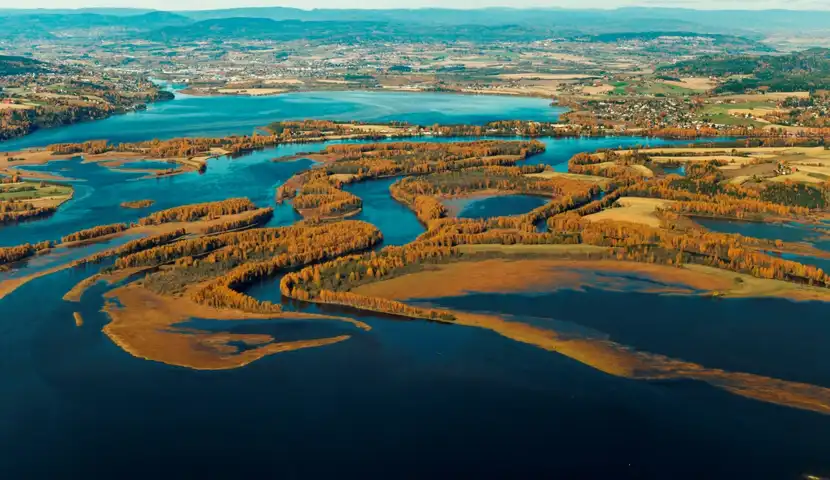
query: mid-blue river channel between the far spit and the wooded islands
[{"left": 0, "top": 134, "right": 688, "bottom": 246}]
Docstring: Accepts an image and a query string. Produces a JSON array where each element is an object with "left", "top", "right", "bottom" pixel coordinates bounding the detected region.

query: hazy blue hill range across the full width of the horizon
[{"left": 0, "top": 7, "right": 830, "bottom": 41}]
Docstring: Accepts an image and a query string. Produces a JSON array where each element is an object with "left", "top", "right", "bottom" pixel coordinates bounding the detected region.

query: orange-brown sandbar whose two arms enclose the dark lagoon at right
[{"left": 354, "top": 260, "right": 830, "bottom": 415}]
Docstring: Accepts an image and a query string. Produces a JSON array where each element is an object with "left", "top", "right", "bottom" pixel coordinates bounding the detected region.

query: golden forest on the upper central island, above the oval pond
[{"left": 276, "top": 140, "right": 556, "bottom": 221}]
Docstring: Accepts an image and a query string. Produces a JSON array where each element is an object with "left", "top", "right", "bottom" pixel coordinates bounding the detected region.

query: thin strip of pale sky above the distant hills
[{"left": 6, "top": 0, "right": 830, "bottom": 10}]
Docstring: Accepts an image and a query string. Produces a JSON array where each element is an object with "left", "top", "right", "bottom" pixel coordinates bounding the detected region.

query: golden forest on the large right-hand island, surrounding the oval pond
[{"left": 272, "top": 139, "right": 830, "bottom": 321}]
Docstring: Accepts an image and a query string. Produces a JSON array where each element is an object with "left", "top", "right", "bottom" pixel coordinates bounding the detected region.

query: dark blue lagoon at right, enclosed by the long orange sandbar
[{"left": 426, "top": 288, "right": 830, "bottom": 388}]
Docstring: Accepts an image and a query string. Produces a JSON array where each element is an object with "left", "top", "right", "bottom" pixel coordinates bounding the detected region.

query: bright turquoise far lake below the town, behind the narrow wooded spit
[{"left": 0, "top": 92, "right": 564, "bottom": 151}]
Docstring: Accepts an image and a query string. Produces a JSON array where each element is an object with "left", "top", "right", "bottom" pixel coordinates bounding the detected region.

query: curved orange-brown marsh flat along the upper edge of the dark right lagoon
[{"left": 352, "top": 255, "right": 830, "bottom": 302}]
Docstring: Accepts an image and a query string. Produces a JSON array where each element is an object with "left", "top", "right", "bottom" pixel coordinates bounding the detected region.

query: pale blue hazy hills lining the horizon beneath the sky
[{"left": 0, "top": 7, "right": 830, "bottom": 36}]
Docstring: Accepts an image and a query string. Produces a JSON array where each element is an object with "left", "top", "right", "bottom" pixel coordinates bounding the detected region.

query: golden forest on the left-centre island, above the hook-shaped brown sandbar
[{"left": 99, "top": 217, "right": 382, "bottom": 313}]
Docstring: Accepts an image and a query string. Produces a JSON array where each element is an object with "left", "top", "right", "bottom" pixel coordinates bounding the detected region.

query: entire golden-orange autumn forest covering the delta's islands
[{"left": 17, "top": 135, "right": 830, "bottom": 328}]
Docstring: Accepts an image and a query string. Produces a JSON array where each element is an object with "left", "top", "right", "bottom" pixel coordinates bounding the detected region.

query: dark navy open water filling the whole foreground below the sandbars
[{"left": 0, "top": 264, "right": 830, "bottom": 478}]
